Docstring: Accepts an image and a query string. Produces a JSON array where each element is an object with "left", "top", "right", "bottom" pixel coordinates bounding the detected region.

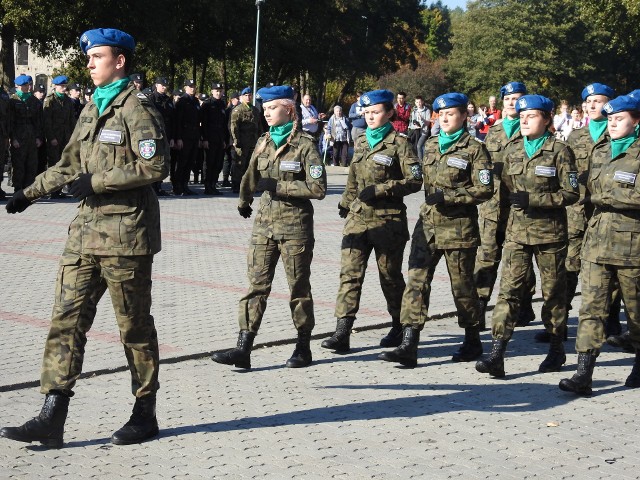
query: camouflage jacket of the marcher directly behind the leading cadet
[{"left": 238, "top": 131, "right": 327, "bottom": 240}]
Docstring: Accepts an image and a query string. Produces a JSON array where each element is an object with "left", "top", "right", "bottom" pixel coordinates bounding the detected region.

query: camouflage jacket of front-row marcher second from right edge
[{"left": 502, "top": 136, "right": 579, "bottom": 245}]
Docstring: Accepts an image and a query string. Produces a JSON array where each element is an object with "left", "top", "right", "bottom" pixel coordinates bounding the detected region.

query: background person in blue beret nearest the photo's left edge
[{"left": 9, "top": 75, "right": 44, "bottom": 191}]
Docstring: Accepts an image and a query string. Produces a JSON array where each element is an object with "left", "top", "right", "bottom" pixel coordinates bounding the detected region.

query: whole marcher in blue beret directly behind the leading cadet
[{"left": 212, "top": 85, "right": 327, "bottom": 368}]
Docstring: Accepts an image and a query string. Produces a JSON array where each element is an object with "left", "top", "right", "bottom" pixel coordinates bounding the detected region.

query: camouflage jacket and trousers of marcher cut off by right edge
[{"left": 576, "top": 140, "right": 640, "bottom": 352}]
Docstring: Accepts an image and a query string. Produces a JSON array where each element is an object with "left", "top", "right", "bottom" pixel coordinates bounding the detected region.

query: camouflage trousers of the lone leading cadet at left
[{"left": 40, "top": 250, "right": 159, "bottom": 397}]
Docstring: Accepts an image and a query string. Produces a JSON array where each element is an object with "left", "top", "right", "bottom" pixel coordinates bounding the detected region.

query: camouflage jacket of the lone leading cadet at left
[{"left": 24, "top": 87, "right": 169, "bottom": 256}]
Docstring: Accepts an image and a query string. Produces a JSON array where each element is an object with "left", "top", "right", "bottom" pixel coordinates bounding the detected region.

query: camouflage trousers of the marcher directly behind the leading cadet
[{"left": 238, "top": 234, "right": 315, "bottom": 333}]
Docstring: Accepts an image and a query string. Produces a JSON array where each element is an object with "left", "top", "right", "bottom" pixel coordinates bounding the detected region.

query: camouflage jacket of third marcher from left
[{"left": 340, "top": 130, "right": 422, "bottom": 242}]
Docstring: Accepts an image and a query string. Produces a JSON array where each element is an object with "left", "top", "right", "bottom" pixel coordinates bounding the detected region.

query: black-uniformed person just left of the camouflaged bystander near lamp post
[{"left": 201, "top": 82, "right": 229, "bottom": 195}]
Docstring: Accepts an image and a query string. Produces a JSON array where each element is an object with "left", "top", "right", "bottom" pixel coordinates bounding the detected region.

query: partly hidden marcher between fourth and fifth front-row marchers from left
[{"left": 473, "top": 82, "right": 536, "bottom": 330}]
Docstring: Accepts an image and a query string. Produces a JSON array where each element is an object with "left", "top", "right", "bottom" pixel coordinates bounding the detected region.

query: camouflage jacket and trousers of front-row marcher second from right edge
[{"left": 492, "top": 136, "right": 579, "bottom": 341}]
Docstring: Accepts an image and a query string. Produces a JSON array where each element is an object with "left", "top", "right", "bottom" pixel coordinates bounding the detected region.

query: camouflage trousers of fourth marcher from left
[{"left": 400, "top": 225, "right": 480, "bottom": 330}]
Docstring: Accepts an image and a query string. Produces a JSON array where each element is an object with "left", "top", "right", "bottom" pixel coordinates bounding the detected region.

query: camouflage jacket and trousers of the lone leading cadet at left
[{"left": 24, "top": 87, "right": 168, "bottom": 397}]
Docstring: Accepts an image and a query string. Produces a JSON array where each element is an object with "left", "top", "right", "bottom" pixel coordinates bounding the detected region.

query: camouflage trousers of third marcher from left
[{"left": 335, "top": 231, "right": 407, "bottom": 318}]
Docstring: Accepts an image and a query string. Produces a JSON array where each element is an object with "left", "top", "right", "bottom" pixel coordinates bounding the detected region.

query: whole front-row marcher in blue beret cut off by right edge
[{"left": 560, "top": 95, "right": 640, "bottom": 395}]
